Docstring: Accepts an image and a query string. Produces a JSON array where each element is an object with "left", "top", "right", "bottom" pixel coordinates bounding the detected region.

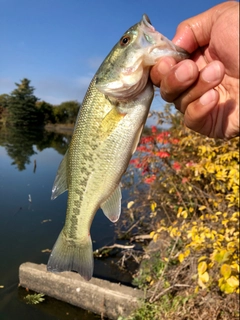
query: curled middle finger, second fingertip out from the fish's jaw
[{"left": 160, "top": 60, "right": 199, "bottom": 102}]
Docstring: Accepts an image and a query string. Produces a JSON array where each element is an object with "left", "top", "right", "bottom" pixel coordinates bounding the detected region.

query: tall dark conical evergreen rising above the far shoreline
[{"left": 7, "top": 78, "right": 40, "bottom": 127}]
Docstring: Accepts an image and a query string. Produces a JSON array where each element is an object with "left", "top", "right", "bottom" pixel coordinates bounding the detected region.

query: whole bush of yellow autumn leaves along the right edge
[{"left": 152, "top": 135, "right": 239, "bottom": 294}]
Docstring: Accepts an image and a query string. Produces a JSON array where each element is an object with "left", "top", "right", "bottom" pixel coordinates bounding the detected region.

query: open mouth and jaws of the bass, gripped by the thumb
[{"left": 140, "top": 14, "right": 190, "bottom": 62}]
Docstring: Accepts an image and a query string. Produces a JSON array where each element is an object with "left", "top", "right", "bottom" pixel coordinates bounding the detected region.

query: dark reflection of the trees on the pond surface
[{"left": 0, "top": 128, "right": 71, "bottom": 171}]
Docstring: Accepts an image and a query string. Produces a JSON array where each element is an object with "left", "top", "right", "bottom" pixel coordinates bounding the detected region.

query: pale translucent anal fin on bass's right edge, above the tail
[{"left": 100, "top": 186, "right": 122, "bottom": 222}]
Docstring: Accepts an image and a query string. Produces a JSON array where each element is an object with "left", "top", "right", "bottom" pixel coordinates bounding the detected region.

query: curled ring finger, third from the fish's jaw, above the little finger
[{"left": 173, "top": 61, "right": 225, "bottom": 113}]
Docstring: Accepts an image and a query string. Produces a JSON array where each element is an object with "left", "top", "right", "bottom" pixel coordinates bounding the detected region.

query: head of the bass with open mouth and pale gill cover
[{"left": 96, "top": 14, "right": 189, "bottom": 100}]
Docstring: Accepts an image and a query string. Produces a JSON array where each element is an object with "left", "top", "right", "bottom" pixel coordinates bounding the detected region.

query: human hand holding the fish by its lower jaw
[{"left": 150, "top": 1, "right": 239, "bottom": 138}]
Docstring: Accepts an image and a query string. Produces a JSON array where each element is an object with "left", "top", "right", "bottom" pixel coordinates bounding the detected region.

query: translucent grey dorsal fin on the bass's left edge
[{"left": 51, "top": 151, "right": 68, "bottom": 200}]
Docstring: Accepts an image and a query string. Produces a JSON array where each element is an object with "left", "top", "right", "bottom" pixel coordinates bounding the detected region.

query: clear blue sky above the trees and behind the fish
[{"left": 0, "top": 0, "right": 225, "bottom": 104}]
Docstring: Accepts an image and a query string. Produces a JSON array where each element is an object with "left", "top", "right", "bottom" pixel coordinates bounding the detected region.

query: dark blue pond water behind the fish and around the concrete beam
[{"left": 0, "top": 130, "right": 129, "bottom": 320}]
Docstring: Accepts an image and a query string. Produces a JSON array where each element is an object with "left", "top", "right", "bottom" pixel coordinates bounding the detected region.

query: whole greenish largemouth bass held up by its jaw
[{"left": 47, "top": 15, "right": 188, "bottom": 280}]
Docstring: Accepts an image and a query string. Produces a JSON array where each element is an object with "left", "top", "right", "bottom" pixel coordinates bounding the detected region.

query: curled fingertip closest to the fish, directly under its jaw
[{"left": 150, "top": 57, "right": 176, "bottom": 87}]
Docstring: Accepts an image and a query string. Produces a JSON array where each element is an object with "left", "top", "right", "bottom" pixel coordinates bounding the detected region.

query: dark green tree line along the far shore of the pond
[{"left": 0, "top": 78, "right": 81, "bottom": 127}]
